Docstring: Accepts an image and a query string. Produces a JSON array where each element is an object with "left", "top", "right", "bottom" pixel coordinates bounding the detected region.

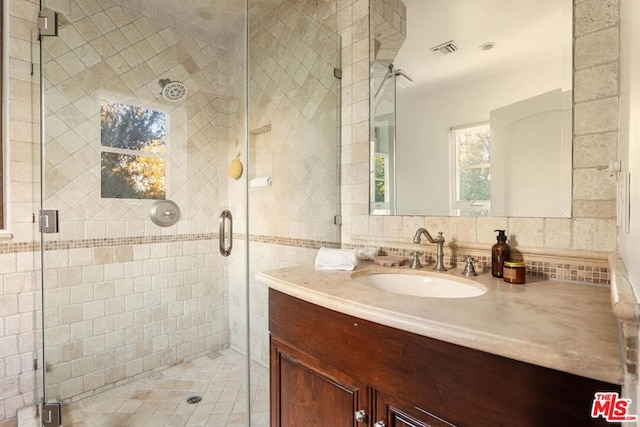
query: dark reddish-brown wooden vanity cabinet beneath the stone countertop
[{"left": 269, "top": 289, "right": 620, "bottom": 427}]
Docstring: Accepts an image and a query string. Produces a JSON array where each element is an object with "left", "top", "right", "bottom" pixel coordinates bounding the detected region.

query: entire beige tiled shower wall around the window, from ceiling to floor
[{"left": 38, "top": 0, "right": 242, "bottom": 408}]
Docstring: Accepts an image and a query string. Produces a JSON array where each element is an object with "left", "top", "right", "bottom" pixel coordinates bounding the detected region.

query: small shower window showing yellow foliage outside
[{"left": 100, "top": 99, "right": 167, "bottom": 200}]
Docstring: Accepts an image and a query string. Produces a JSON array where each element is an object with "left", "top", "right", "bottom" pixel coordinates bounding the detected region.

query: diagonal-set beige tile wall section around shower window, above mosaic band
[{"left": 43, "top": 0, "right": 228, "bottom": 240}]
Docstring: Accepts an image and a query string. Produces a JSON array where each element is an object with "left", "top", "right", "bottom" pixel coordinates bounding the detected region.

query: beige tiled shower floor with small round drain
[{"left": 62, "top": 349, "right": 269, "bottom": 427}]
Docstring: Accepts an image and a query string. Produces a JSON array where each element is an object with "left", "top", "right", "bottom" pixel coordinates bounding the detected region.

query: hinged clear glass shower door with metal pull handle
[{"left": 40, "top": 0, "right": 249, "bottom": 425}]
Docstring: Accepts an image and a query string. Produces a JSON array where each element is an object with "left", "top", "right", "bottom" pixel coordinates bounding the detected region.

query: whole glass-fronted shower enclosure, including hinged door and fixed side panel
[{"left": 39, "top": 0, "right": 340, "bottom": 425}]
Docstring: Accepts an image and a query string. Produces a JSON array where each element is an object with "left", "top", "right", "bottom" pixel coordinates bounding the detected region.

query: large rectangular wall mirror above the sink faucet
[{"left": 370, "top": 0, "right": 573, "bottom": 217}]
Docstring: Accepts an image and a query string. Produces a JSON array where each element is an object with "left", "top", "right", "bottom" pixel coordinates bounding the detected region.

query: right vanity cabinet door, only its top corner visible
[{"left": 372, "top": 390, "right": 455, "bottom": 427}]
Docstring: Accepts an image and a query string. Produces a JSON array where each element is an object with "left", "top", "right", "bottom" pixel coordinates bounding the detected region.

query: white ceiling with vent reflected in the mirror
[{"left": 394, "top": 0, "right": 572, "bottom": 86}]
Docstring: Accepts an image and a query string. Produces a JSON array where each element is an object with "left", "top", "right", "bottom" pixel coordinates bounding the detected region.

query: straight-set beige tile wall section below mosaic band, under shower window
[{"left": 44, "top": 241, "right": 229, "bottom": 402}]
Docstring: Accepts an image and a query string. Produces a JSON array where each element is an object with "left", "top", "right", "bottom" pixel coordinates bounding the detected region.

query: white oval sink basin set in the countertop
[{"left": 351, "top": 272, "right": 487, "bottom": 298}]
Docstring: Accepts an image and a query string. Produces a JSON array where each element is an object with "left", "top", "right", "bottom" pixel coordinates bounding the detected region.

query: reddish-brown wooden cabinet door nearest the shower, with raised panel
[{"left": 270, "top": 337, "right": 367, "bottom": 427}]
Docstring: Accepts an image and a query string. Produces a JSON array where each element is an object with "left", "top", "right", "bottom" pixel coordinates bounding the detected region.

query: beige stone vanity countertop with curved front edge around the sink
[{"left": 256, "top": 262, "right": 623, "bottom": 384}]
